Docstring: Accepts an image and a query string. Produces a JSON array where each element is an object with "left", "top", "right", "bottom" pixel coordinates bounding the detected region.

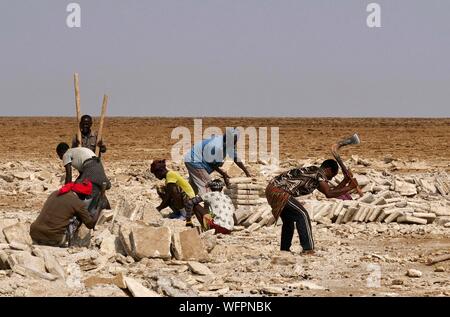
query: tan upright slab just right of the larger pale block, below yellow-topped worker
[{"left": 172, "top": 228, "right": 209, "bottom": 262}]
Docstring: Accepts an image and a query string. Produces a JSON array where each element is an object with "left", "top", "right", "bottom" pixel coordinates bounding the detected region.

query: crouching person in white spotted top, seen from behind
[{"left": 201, "top": 179, "right": 234, "bottom": 234}]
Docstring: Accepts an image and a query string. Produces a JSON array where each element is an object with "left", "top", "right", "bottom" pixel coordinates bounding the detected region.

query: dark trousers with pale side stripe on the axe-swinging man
[{"left": 280, "top": 197, "right": 314, "bottom": 251}]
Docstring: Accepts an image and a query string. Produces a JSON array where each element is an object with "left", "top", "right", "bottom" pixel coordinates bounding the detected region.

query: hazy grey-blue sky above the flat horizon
[{"left": 0, "top": 0, "right": 450, "bottom": 117}]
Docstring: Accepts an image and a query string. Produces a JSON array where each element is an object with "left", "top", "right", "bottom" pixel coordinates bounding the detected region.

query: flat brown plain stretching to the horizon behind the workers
[{"left": 0, "top": 117, "right": 450, "bottom": 162}]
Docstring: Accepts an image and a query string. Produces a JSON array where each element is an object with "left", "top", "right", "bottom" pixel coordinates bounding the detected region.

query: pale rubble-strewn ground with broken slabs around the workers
[{"left": 0, "top": 160, "right": 450, "bottom": 296}]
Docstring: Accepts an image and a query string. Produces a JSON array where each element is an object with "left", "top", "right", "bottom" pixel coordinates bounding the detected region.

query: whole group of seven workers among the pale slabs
[{"left": 30, "top": 115, "right": 357, "bottom": 253}]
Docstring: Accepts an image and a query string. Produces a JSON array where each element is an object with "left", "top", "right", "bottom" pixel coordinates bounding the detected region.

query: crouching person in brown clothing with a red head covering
[{"left": 30, "top": 180, "right": 100, "bottom": 247}]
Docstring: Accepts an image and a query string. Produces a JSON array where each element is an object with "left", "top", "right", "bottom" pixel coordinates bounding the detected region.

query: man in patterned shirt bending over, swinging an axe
[{"left": 266, "top": 133, "right": 359, "bottom": 254}]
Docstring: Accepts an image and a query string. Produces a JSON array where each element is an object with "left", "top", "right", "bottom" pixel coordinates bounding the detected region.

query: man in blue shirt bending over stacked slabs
[{"left": 184, "top": 129, "right": 251, "bottom": 195}]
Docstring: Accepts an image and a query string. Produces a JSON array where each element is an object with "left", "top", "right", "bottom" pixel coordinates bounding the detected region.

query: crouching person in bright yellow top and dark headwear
[{"left": 150, "top": 160, "right": 206, "bottom": 227}]
